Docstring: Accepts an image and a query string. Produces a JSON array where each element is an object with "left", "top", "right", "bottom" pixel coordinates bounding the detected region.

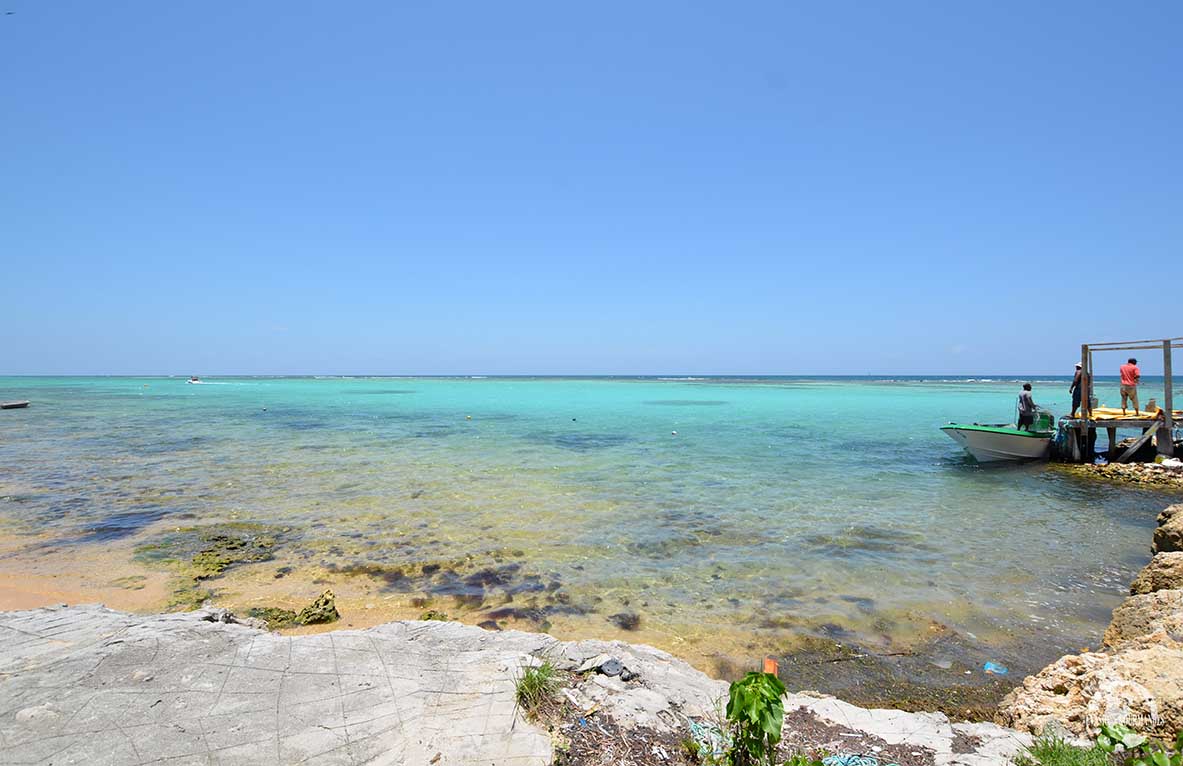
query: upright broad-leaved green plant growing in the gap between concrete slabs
[{"left": 726, "top": 671, "right": 784, "bottom": 766}]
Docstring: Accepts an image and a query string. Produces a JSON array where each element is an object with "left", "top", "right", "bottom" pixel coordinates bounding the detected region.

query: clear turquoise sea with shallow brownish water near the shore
[{"left": 0, "top": 376, "right": 1169, "bottom": 669}]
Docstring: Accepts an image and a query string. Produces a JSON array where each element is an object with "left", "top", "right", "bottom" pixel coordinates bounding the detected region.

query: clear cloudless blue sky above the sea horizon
[{"left": 0, "top": 0, "right": 1183, "bottom": 375}]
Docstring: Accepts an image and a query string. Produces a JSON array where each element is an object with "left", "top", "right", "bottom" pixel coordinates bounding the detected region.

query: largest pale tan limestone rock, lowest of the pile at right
[{"left": 996, "top": 644, "right": 1183, "bottom": 738}]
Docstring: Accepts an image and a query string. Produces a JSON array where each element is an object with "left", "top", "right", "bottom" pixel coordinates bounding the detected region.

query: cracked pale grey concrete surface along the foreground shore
[{"left": 0, "top": 606, "right": 1030, "bottom": 766}]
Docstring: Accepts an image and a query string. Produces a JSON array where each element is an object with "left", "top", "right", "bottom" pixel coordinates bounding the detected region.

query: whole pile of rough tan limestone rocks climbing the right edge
[{"left": 995, "top": 504, "right": 1183, "bottom": 738}]
